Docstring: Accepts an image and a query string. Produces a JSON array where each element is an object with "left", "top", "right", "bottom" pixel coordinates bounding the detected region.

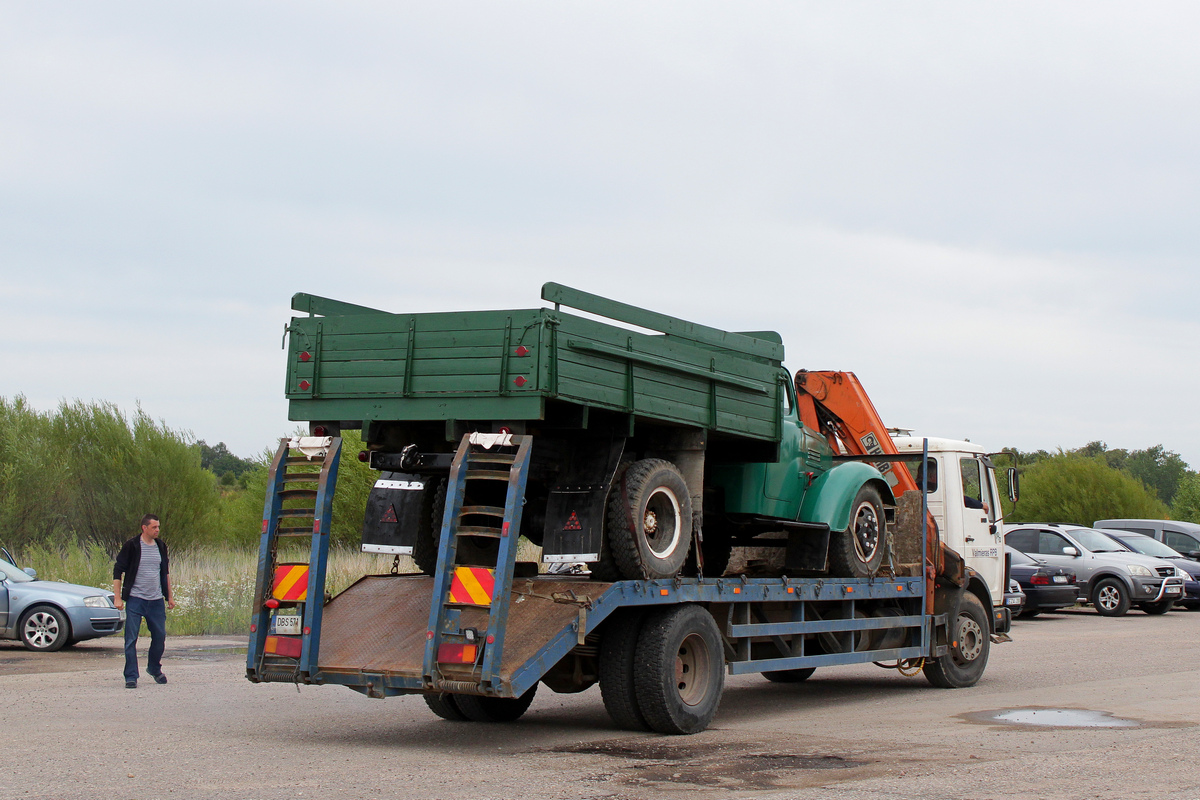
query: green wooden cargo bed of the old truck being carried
[{"left": 287, "top": 283, "right": 788, "bottom": 443}]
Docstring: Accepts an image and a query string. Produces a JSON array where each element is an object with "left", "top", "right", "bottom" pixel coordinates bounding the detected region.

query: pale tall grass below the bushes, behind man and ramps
[{"left": 14, "top": 543, "right": 416, "bottom": 636}]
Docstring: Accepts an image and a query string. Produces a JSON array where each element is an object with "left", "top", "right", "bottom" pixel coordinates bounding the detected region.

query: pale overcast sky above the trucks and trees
[{"left": 0, "top": 0, "right": 1200, "bottom": 468}]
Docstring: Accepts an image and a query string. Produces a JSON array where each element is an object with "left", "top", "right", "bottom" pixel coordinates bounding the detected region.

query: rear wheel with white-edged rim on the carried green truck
[{"left": 605, "top": 458, "right": 691, "bottom": 581}]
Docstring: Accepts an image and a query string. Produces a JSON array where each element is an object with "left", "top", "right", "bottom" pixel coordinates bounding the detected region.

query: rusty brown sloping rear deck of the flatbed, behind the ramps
[{"left": 318, "top": 575, "right": 612, "bottom": 682}]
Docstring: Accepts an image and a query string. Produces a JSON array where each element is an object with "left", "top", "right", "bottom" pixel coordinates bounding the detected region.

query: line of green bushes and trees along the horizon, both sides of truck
[{"left": 0, "top": 396, "right": 1200, "bottom": 553}]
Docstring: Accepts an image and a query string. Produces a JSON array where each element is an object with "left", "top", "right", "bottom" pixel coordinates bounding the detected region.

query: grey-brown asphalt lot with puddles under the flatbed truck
[{"left": 0, "top": 609, "right": 1200, "bottom": 800}]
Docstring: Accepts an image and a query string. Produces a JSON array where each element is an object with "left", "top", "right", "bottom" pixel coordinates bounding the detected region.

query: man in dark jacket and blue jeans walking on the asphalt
[{"left": 113, "top": 513, "right": 175, "bottom": 688}]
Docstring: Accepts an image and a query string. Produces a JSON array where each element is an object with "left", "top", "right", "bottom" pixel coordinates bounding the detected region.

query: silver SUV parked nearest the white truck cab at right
[{"left": 1004, "top": 523, "right": 1186, "bottom": 616}]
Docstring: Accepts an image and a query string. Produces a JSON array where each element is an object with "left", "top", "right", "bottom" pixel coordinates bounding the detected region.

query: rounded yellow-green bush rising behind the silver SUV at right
[{"left": 1009, "top": 453, "right": 1168, "bottom": 525}]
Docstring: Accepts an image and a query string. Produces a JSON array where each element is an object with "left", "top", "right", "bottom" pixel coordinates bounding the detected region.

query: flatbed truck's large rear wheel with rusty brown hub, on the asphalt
[{"left": 635, "top": 603, "right": 725, "bottom": 734}]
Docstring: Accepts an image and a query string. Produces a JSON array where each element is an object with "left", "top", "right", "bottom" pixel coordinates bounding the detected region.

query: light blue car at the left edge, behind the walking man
[{"left": 0, "top": 551, "right": 125, "bottom": 651}]
